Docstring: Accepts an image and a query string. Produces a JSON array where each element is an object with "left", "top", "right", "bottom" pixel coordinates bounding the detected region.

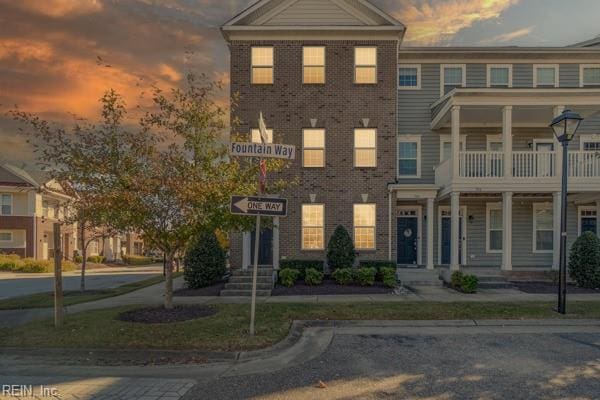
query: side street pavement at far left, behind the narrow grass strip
[{"left": 0, "top": 267, "right": 162, "bottom": 299}]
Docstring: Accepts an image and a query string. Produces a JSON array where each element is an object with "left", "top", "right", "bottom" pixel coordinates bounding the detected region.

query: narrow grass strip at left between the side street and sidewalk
[{"left": 0, "top": 273, "right": 181, "bottom": 310}]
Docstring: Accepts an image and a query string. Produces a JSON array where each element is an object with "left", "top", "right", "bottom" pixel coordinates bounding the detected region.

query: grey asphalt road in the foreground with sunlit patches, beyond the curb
[{"left": 184, "top": 329, "right": 600, "bottom": 400}]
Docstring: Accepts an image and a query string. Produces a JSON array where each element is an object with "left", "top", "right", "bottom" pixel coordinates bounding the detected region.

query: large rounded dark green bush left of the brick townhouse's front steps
[{"left": 183, "top": 232, "right": 227, "bottom": 289}]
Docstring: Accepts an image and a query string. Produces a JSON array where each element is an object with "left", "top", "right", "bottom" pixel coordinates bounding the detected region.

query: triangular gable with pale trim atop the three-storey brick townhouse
[{"left": 221, "top": 0, "right": 406, "bottom": 39}]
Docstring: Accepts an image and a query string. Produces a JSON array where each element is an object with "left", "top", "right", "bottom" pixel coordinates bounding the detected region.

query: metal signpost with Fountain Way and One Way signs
[{"left": 229, "top": 112, "right": 296, "bottom": 336}]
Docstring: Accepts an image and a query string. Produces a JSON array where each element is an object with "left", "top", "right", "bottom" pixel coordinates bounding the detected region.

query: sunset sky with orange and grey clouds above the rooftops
[{"left": 0, "top": 0, "right": 600, "bottom": 166}]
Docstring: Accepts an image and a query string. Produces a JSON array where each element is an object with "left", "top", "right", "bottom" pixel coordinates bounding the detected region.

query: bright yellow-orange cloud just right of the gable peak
[{"left": 394, "top": 0, "right": 519, "bottom": 45}]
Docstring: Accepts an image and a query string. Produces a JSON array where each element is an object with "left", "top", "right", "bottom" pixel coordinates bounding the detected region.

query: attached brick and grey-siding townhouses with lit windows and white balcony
[{"left": 222, "top": 0, "right": 600, "bottom": 271}]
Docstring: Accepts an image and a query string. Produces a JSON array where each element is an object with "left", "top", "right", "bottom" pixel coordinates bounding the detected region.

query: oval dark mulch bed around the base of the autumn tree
[{"left": 118, "top": 305, "right": 217, "bottom": 324}]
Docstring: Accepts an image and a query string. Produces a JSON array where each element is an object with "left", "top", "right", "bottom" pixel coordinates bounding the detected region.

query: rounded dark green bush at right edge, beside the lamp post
[{"left": 569, "top": 232, "right": 600, "bottom": 289}]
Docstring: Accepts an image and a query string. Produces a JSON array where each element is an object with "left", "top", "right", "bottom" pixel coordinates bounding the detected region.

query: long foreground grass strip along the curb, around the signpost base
[{"left": 0, "top": 302, "right": 600, "bottom": 351}]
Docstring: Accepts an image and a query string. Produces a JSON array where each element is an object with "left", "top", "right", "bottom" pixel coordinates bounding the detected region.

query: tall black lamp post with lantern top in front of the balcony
[{"left": 550, "top": 110, "right": 583, "bottom": 314}]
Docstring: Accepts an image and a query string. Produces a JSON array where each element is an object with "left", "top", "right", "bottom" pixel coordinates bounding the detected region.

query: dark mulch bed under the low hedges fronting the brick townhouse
[{"left": 271, "top": 279, "right": 394, "bottom": 296}]
